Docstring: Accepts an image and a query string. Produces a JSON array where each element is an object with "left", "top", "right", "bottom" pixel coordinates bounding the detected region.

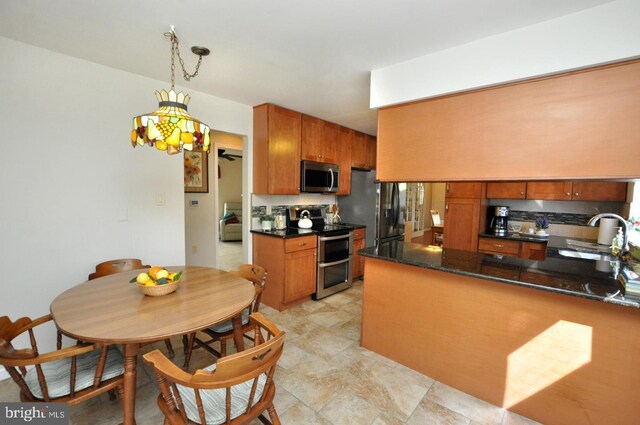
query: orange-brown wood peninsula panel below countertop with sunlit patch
[{"left": 362, "top": 258, "right": 640, "bottom": 425}]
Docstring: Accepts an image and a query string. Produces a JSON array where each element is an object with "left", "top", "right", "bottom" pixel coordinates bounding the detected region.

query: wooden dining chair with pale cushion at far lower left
[{"left": 0, "top": 314, "right": 124, "bottom": 406}]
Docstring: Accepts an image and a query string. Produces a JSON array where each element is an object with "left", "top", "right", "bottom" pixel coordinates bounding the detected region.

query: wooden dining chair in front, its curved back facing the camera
[{"left": 143, "top": 313, "right": 285, "bottom": 425}]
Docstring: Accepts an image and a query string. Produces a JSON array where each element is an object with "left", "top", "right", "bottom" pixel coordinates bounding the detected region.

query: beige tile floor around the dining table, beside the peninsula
[{"left": 0, "top": 281, "right": 537, "bottom": 425}]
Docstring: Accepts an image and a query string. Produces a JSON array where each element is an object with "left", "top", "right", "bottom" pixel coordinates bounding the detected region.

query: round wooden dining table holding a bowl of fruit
[{"left": 51, "top": 266, "right": 255, "bottom": 425}]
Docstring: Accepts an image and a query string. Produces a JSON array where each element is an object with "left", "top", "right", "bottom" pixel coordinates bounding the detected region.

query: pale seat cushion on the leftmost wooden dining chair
[{"left": 24, "top": 347, "right": 124, "bottom": 399}]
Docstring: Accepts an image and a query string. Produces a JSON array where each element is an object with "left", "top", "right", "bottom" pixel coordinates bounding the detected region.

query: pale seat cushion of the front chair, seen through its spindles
[{"left": 176, "top": 363, "right": 267, "bottom": 425}]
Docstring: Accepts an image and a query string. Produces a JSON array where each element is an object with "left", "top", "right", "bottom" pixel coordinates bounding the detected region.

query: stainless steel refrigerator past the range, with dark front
[{"left": 338, "top": 170, "right": 407, "bottom": 246}]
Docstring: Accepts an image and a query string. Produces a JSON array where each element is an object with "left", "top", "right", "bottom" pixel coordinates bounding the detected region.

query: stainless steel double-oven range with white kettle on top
[{"left": 287, "top": 207, "right": 353, "bottom": 300}]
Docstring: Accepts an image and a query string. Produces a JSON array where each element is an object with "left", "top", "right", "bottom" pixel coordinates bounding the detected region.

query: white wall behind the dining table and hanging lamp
[{"left": 0, "top": 37, "right": 252, "bottom": 378}]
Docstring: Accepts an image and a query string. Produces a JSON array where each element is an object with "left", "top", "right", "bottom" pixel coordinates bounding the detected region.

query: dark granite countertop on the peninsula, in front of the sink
[{"left": 358, "top": 236, "right": 640, "bottom": 308}]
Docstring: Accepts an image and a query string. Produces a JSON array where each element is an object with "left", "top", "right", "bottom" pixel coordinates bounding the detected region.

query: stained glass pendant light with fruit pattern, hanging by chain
[{"left": 131, "top": 26, "right": 210, "bottom": 155}]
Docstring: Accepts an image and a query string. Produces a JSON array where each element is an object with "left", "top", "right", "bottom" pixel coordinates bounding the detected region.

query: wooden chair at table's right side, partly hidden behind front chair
[{"left": 183, "top": 264, "right": 267, "bottom": 369}]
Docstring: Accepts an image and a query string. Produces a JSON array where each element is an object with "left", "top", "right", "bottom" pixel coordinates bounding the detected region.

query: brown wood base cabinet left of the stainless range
[{"left": 253, "top": 234, "right": 318, "bottom": 311}]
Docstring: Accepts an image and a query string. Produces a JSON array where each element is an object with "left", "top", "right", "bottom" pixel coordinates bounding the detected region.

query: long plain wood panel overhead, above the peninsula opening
[{"left": 377, "top": 60, "right": 640, "bottom": 181}]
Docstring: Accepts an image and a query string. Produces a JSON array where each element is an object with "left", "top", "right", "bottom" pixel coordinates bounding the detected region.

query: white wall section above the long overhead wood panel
[{"left": 370, "top": 0, "right": 640, "bottom": 108}]
